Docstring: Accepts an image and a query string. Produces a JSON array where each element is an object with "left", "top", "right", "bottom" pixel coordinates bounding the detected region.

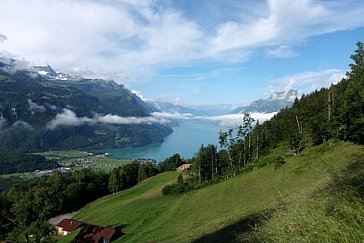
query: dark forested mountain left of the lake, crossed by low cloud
[{"left": 0, "top": 58, "right": 172, "bottom": 152}]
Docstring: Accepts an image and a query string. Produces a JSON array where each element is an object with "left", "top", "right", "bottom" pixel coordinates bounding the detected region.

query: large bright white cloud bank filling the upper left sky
[{"left": 0, "top": 0, "right": 201, "bottom": 79}]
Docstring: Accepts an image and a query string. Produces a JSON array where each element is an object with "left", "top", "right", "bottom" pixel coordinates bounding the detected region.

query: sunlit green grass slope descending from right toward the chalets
[{"left": 74, "top": 142, "right": 364, "bottom": 242}]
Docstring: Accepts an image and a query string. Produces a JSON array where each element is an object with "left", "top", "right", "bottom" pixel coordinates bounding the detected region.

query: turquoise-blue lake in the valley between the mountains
[{"left": 97, "top": 120, "right": 226, "bottom": 162}]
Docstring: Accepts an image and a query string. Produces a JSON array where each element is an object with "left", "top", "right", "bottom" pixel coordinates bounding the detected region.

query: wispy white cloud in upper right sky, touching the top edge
[{"left": 211, "top": 0, "right": 329, "bottom": 52}]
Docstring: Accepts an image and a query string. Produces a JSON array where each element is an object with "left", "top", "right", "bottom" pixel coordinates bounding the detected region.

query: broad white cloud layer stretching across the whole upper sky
[{"left": 0, "top": 0, "right": 364, "bottom": 82}]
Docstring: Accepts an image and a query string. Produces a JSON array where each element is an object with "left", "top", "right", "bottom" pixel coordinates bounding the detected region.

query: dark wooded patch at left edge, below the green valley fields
[{"left": 0, "top": 153, "right": 59, "bottom": 174}]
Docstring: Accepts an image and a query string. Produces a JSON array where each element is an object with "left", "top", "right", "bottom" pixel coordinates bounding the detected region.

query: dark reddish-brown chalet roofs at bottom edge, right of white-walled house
[{"left": 72, "top": 224, "right": 121, "bottom": 243}]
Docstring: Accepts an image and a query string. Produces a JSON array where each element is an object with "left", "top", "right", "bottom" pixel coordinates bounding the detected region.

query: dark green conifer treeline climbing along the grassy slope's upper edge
[{"left": 165, "top": 42, "right": 364, "bottom": 194}]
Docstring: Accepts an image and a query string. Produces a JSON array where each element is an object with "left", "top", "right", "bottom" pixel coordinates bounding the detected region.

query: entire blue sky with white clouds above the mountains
[{"left": 0, "top": 0, "right": 364, "bottom": 105}]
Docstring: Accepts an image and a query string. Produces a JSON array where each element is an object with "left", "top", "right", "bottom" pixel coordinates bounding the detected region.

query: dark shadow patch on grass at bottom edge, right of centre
[{"left": 193, "top": 210, "right": 273, "bottom": 243}]
